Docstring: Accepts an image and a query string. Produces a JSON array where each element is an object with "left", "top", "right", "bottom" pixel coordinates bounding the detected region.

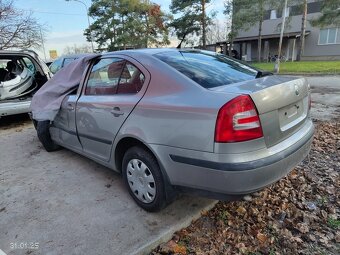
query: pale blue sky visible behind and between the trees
[{"left": 14, "top": 0, "right": 223, "bottom": 58}]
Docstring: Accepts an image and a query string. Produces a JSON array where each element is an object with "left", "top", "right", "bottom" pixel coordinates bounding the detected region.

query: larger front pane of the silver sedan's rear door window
[{"left": 85, "top": 58, "right": 125, "bottom": 95}]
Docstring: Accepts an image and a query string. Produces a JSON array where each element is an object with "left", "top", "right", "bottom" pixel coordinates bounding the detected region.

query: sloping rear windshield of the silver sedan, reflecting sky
[{"left": 155, "top": 51, "right": 257, "bottom": 89}]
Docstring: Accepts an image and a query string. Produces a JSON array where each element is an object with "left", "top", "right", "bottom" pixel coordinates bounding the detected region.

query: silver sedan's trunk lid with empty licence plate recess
[{"left": 211, "top": 76, "right": 309, "bottom": 147}]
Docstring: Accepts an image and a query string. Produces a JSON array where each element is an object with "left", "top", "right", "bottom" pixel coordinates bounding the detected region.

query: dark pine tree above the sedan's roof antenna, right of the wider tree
[{"left": 170, "top": 0, "right": 214, "bottom": 49}]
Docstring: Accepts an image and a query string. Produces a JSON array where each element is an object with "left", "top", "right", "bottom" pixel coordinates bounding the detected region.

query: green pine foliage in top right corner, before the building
[{"left": 311, "top": 0, "right": 340, "bottom": 28}]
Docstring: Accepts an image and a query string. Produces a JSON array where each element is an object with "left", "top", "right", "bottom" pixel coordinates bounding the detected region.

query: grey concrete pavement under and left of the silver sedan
[{"left": 0, "top": 115, "right": 215, "bottom": 255}]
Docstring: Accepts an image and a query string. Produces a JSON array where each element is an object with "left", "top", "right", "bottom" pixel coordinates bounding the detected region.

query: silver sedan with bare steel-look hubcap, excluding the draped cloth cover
[{"left": 33, "top": 49, "right": 314, "bottom": 211}]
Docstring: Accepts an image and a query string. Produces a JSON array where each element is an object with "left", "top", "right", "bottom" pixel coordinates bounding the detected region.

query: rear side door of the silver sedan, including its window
[{"left": 76, "top": 57, "right": 145, "bottom": 161}]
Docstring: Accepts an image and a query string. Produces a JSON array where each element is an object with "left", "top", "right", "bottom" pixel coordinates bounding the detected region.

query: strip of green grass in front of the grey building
[{"left": 252, "top": 61, "right": 340, "bottom": 74}]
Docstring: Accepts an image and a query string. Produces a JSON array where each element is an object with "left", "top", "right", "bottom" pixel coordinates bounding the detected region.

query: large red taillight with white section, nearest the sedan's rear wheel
[{"left": 215, "top": 95, "right": 263, "bottom": 143}]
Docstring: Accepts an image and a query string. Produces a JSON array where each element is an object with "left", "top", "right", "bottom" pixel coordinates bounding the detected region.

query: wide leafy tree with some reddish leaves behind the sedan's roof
[{"left": 84, "top": 0, "right": 169, "bottom": 50}]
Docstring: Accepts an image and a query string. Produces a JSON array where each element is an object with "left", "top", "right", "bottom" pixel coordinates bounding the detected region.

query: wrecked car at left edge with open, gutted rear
[{"left": 0, "top": 50, "right": 52, "bottom": 117}]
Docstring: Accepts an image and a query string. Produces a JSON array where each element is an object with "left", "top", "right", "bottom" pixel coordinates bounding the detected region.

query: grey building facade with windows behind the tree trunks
[{"left": 228, "top": 0, "right": 340, "bottom": 61}]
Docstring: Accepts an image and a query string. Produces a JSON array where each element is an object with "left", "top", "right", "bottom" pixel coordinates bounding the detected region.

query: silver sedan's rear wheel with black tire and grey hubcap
[{"left": 122, "top": 146, "right": 167, "bottom": 212}]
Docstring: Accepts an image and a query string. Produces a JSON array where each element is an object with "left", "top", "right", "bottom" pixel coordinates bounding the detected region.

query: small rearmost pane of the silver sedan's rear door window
[{"left": 117, "top": 62, "right": 145, "bottom": 94}]
